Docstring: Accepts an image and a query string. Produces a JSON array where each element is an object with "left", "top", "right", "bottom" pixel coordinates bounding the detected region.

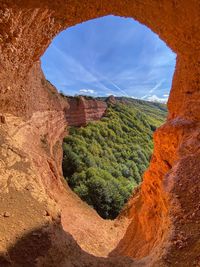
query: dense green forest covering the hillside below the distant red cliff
[{"left": 63, "top": 98, "right": 167, "bottom": 219}]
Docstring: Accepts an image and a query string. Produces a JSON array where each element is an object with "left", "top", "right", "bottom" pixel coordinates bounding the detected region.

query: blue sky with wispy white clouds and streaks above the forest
[{"left": 41, "top": 15, "right": 176, "bottom": 102}]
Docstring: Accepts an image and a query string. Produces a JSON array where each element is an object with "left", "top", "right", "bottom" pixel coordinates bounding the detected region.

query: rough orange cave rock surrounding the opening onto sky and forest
[{"left": 0, "top": 0, "right": 200, "bottom": 267}]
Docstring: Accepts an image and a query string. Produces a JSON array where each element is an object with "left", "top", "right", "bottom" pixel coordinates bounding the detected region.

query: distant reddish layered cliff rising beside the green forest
[{"left": 66, "top": 96, "right": 107, "bottom": 126}]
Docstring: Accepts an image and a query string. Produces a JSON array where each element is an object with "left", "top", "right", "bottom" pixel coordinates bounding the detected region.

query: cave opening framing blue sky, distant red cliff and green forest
[{"left": 42, "top": 13, "right": 175, "bottom": 219}]
